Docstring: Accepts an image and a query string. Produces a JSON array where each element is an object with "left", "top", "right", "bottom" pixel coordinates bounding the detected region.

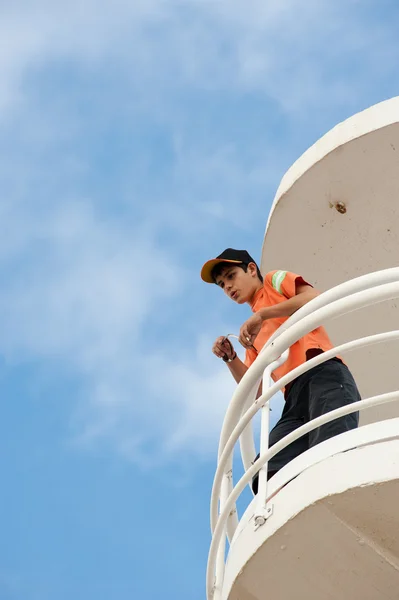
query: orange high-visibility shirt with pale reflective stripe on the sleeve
[{"left": 244, "top": 271, "right": 333, "bottom": 381}]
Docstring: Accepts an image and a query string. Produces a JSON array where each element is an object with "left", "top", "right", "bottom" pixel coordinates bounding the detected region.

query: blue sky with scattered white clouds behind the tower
[{"left": 0, "top": 0, "right": 399, "bottom": 600}]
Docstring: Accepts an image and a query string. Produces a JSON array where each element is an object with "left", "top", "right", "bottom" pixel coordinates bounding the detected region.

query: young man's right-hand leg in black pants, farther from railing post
[{"left": 307, "top": 360, "right": 361, "bottom": 447}]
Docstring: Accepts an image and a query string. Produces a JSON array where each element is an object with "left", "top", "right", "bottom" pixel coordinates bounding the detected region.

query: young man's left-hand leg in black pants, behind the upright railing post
[{"left": 252, "top": 414, "right": 309, "bottom": 494}]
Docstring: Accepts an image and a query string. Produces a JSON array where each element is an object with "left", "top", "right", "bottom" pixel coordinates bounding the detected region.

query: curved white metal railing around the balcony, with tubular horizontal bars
[{"left": 207, "top": 268, "right": 399, "bottom": 600}]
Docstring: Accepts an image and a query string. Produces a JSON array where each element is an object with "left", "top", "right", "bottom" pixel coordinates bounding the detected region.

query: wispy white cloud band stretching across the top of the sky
[{"left": 0, "top": 0, "right": 397, "bottom": 119}]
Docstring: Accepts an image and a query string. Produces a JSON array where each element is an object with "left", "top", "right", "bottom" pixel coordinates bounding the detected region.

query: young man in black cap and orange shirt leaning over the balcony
[{"left": 201, "top": 248, "right": 361, "bottom": 493}]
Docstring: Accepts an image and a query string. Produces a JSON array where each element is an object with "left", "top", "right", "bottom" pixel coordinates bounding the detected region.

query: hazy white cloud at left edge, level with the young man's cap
[{"left": 0, "top": 199, "right": 178, "bottom": 369}]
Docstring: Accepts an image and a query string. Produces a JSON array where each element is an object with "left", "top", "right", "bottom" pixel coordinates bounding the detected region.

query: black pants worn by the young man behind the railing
[{"left": 252, "top": 358, "right": 361, "bottom": 494}]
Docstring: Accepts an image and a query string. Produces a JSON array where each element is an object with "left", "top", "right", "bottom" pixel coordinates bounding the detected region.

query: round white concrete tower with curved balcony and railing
[{"left": 207, "top": 98, "right": 399, "bottom": 600}]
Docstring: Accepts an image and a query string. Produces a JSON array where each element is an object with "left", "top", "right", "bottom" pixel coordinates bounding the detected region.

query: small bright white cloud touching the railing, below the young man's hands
[{"left": 76, "top": 351, "right": 238, "bottom": 467}]
